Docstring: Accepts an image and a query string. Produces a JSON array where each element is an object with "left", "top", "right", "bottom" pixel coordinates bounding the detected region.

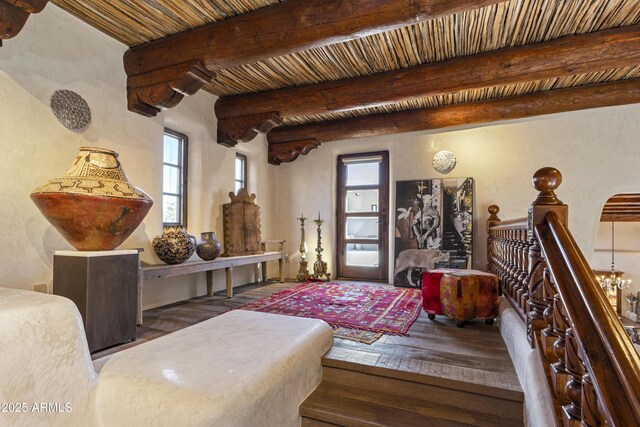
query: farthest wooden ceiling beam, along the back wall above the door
[{"left": 267, "top": 79, "right": 640, "bottom": 165}]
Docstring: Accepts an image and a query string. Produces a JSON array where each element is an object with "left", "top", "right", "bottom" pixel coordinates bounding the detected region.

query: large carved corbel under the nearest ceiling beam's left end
[{"left": 127, "top": 61, "right": 216, "bottom": 117}]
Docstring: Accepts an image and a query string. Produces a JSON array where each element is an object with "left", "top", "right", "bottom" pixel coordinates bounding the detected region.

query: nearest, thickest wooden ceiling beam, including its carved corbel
[{"left": 124, "top": 0, "right": 505, "bottom": 116}]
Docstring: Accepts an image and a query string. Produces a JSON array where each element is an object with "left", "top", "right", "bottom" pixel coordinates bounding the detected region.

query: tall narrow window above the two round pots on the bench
[{"left": 162, "top": 129, "right": 188, "bottom": 227}]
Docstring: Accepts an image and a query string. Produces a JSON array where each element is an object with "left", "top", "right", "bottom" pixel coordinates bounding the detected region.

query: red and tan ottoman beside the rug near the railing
[{"left": 422, "top": 268, "right": 499, "bottom": 327}]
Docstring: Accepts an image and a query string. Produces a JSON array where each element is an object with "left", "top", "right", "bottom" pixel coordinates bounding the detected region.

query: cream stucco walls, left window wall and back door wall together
[{"left": 5, "top": 5, "right": 640, "bottom": 307}]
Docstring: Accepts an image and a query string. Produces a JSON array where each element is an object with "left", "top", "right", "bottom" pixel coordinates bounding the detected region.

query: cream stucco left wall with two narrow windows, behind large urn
[{"left": 0, "top": 4, "right": 277, "bottom": 307}]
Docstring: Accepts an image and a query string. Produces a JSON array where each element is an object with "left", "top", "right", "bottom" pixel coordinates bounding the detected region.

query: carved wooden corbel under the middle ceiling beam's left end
[{"left": 218, "top": 111, "right": 282, "bottom": 147}]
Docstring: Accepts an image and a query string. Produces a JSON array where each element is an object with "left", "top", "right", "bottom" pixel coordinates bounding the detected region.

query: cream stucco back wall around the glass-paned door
[{"left": 276, "top": 105, "right": 640, "bottom": 279}]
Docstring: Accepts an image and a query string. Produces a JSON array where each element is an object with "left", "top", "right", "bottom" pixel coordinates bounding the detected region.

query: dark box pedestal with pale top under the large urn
[{"left": 53, "top": 250, "right": 138, "bottom": 352}]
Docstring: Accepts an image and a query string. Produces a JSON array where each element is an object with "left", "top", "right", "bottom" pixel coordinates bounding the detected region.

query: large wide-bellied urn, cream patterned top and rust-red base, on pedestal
[{"left": 31, "top": 147, "right": 153, "bottom": 251}]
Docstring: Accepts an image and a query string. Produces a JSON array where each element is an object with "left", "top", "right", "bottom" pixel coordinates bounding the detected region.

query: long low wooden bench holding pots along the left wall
[{"left": 138, "top": 250, "right": 284, "bottom": 324}]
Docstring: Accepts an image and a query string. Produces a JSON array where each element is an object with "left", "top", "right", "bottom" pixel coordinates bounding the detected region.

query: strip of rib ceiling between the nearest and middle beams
[{"left": 205, "top": 0, "right": 640, "bottom": 96}]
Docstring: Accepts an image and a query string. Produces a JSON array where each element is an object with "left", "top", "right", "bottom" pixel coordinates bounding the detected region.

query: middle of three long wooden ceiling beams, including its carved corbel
[{"left": 215, "top": 26, "right": 640, "bottom": 146}]
